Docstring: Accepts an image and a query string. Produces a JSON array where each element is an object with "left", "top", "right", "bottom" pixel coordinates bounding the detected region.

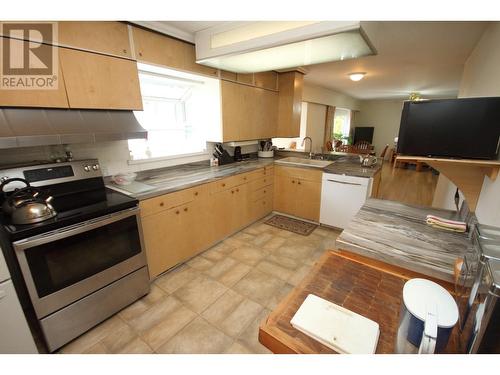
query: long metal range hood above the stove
[{"left": 0, "top": 108, "right": 147, "bottom": 148}]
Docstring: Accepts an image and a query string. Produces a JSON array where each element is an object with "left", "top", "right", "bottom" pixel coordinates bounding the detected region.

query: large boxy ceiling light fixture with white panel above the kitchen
[{"left": 195, "top": 21, "right": 376, "bottom": 73}]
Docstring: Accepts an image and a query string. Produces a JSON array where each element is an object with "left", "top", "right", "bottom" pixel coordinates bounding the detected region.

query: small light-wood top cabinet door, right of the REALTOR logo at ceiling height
[{"left": 58, "top": 21, "right": 133, "bottom": 58}]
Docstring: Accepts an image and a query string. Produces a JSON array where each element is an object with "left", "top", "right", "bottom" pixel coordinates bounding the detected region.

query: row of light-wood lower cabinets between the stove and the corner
[{"left": 140, "top": 168, "right": 273, "bottom": 278}]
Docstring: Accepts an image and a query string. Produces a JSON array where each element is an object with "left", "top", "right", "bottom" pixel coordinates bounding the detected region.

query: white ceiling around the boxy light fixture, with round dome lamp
[{"left": 147, "top": 21, "right": 488, "bottom": 99}]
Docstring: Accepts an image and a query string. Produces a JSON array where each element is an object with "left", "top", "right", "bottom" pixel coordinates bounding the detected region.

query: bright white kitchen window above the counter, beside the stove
[{"left": 128, "top": 64, "right": 220, "bottom": 160}]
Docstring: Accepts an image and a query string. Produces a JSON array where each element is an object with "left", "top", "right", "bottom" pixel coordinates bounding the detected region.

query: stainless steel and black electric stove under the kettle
[{"left": 0, "top": 160, "right": 149, "bottom": 352}]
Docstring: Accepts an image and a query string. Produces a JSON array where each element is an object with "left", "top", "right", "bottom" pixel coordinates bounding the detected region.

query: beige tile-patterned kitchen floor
[{"left": 60, "top": 218, "right": 339, "bottom": 353}]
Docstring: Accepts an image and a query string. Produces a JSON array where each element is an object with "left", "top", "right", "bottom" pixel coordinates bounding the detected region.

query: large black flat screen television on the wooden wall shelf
[{"left": 398, "top": 97, "right": 500, "bottom": 159}]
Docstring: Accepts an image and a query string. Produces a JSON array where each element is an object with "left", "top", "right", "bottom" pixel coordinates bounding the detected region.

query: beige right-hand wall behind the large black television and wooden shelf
[{"left": 433, "top": 22, "right": 500, "bottom": 226}]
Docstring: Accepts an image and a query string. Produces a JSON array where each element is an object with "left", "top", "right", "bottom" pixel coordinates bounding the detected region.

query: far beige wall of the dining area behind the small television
[{"left": 353, "top": 100, "right": 403, "bottom": 154}]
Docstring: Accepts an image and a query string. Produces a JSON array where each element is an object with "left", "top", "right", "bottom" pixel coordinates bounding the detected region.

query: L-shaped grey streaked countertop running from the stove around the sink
[{"left": 105, "top": 153, "right": 382, "bottom": 200}]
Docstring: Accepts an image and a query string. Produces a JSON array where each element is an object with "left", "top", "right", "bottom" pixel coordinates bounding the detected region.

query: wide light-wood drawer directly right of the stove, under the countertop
[{"left": 139, "top": 185, "right": 207, "bottom": 216}]
